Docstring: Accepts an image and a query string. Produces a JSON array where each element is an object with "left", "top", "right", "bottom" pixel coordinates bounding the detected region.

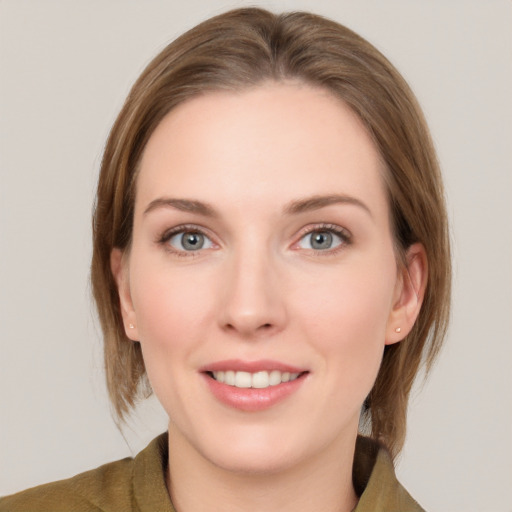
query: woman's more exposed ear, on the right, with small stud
[{"left": 386, "top": 243, "right": 428, "bottom": 345}]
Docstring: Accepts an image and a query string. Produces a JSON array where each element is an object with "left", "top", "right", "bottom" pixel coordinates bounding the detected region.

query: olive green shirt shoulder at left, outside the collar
[{"left": 0, "top": 458, "right": 133, "bottom": 512}]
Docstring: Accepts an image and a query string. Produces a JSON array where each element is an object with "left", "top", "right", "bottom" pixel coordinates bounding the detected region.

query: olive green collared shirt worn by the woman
[{"left": 0, "top": 433, "right": 423, "bottom": 512}]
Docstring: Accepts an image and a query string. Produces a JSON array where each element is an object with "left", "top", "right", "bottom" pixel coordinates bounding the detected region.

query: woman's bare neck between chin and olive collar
[{"left": 167, "top": 427, "right": 357, "bottom": 512}]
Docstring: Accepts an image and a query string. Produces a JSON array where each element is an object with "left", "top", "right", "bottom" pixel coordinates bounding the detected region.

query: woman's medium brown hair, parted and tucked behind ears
[{"left": 91, "top": 8, "right": 451, "bottom": 456}]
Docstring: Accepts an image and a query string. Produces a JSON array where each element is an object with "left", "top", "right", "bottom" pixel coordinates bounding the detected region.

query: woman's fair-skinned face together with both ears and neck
[{"left": 112, "top": 83, "right": 426, "bottom": 512}]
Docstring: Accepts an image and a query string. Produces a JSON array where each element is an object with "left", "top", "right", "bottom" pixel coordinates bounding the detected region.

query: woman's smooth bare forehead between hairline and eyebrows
[{"left": 136, "top": 83, "right": 385, "bottom": 218}]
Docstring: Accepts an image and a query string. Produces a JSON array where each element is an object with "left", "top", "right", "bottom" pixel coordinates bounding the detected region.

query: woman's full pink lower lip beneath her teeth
[{"left": 203, "top": 373, "right": 307, "bottom": 412}]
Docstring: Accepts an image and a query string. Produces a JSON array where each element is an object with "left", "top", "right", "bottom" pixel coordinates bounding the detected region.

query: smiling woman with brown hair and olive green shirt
[{"left": 0, "top": 9, "right": 450, "bottom": 512}]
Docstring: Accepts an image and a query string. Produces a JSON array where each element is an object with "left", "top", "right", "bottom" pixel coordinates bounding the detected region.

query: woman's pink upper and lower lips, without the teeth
[{"left": 200, "top": 359, "right": 309, "bottom": 412}]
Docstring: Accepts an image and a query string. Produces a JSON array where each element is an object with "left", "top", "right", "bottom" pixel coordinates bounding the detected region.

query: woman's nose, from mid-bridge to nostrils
[{"left": 219, "top": 248, "right": 287, "bottom": 339}]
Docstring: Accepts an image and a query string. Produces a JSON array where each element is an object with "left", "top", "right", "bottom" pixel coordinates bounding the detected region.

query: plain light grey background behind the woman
[{"left": 0, "top": 0, "right": 512, "bottom": 512}]
